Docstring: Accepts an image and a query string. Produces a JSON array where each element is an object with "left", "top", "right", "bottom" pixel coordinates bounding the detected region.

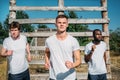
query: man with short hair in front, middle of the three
[{"left": 45, "top": 15, "right": 81, "bottom": 80}]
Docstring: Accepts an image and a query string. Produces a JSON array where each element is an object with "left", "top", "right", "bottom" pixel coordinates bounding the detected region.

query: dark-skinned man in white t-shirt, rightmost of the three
[{"left": 85, "top": 29, "right": 107, "bottom": 80}]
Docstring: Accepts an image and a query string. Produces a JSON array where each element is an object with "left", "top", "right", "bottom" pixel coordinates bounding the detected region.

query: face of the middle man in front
[{"left": 56, "top": 18, "right": 68, "bottom": 32}]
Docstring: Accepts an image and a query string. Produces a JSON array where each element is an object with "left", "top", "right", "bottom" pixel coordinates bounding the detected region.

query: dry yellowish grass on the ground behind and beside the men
[{"left": 0, "top": 55, "right": 120, "bottom": 80}]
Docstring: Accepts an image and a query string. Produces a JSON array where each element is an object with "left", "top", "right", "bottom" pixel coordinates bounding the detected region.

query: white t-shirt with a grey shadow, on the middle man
[{"left": 45, "top": 35, "right": 80, "bottom": 80}]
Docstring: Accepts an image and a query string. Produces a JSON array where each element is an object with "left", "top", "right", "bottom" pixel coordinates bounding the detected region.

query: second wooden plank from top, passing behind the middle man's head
[{"left": 9, "top": 18, "right": 109, "bottom": 24}]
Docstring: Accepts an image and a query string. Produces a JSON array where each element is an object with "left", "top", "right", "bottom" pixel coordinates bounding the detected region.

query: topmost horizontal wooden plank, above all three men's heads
[{"left": 9, "top": 6, "right": 107, "bottom": 11}]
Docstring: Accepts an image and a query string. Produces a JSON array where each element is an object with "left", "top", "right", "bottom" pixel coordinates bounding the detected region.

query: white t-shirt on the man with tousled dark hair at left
[{"left": 3, "top": 35, "right": 28, "bottom": 74}]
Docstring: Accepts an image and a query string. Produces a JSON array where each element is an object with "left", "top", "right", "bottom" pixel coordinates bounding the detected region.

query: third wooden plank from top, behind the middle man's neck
[{"left": 21, "top": 31, "right": 109, "bottom": 37}]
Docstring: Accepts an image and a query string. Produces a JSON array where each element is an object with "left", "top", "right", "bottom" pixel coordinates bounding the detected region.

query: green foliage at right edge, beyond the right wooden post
[{"left": 110, "top": 28, "right": 120, "bottom": 54}]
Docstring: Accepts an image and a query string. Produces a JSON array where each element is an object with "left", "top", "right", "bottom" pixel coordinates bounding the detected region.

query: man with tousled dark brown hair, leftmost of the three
[{"left": 1, "top": 22, "right": 31, "bottom": 80}]
